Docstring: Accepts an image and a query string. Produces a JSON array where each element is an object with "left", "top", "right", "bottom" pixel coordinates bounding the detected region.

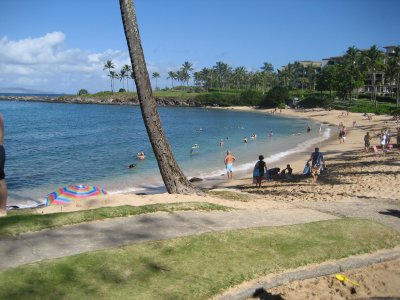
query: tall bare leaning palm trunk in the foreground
[{"left": 119, "top": 0, "right": 198, "bottom": 194}]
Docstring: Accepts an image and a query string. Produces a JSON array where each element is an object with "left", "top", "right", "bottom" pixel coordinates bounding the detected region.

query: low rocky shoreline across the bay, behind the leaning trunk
[{"left": 0, "top": 94, "right": 198, "bottom": 107}]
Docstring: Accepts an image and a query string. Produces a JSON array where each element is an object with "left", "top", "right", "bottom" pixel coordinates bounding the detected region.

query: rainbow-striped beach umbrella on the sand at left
[{"left": 46, "top": 185, "right": 107, "bottom": 206}]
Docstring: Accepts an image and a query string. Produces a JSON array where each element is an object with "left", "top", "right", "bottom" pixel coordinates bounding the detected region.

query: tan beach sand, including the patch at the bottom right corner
[{"left": 37, "top": 107, "right": 400, "bottom": 299}]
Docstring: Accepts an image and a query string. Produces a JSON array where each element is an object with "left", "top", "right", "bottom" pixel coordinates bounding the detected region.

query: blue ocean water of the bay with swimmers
[{"left": 0, "top": 101, "right": 330, "bottom": 207}]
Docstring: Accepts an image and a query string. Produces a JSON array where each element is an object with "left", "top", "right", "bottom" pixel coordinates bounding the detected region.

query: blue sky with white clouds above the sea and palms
[{"left": 0, "top": 0, "right": 400, "bottom": 94}]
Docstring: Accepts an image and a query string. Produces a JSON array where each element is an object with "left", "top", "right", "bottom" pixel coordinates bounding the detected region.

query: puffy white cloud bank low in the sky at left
[{"left": 0, "top": 32, "right": 130, "bottom": 92}]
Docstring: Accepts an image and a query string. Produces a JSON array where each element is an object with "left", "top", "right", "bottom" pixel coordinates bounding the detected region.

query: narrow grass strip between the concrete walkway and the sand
[{"left": 0, "top": 202, "right": 229, "bottom": 236}]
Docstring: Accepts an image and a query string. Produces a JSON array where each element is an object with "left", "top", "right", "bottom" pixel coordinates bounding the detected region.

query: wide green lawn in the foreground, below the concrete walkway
[{"left": 0, "top": 219, "right": 400, "bottom": 300}]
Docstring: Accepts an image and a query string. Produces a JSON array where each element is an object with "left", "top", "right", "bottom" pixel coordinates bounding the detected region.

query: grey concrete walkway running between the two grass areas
[{"left": 0, "top": 208, "right": 338, "bottom": 269}]
